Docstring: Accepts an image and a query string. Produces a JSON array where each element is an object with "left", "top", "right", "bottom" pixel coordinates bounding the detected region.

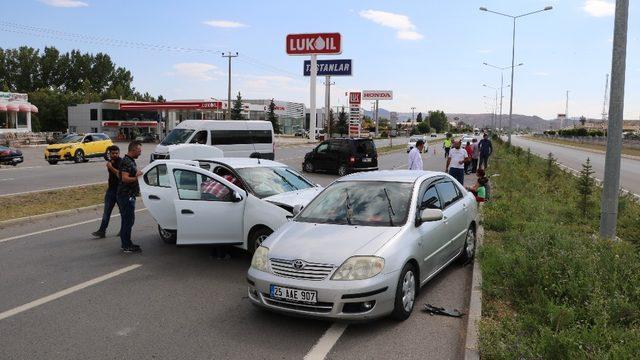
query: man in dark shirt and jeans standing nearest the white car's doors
[{"left": 118, "top": 140, "right": 142, "bottom": 253}]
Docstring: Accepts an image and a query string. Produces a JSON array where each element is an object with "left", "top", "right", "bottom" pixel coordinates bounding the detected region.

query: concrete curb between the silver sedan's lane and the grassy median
[{"left": 464, "top": 225, "right": 484, "bottom": 360}]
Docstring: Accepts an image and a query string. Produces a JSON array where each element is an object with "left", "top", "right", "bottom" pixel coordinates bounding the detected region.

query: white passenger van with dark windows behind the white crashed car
[{"left": 151, "top": 120, "right": 275, "bottom": 161}]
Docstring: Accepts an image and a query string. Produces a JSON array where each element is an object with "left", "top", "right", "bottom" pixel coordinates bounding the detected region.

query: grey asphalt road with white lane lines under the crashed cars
[{"left": 0, "top": 147, "right": 471, "bottom": 360}]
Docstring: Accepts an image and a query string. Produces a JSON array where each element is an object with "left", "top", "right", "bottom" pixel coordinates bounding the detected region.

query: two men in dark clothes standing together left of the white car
[{"left": 92, "top": 141, "right": 142, "bottom": 253}]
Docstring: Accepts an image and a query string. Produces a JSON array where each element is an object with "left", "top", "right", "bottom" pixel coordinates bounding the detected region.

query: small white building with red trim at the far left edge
[{"left": 0, "top": 92, "right": 38, "bottom": 133}]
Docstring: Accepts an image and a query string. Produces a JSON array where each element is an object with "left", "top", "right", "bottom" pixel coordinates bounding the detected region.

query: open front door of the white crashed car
[{"left": 167, "top": 164, "right": 248, "bottom": 245}]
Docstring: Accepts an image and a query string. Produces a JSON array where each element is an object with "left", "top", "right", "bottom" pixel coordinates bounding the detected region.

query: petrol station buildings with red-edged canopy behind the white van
[{"left": 68, "top": 99, "right": 304, "bottom": 140}]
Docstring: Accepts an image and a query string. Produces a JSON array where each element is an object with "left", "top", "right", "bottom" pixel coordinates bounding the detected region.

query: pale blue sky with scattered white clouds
[{"left": 0, "top": 0, "right": 640, "bottom": 119}]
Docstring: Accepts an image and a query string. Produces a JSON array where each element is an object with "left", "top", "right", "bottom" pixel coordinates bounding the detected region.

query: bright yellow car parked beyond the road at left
[{"left": 44, "top": 133, "right": 113, "bottom": 165}]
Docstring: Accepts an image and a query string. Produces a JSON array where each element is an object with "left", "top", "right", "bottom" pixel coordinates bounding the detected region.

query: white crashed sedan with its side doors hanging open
[{"left": 139, "top": 158, "right": 322, "bottom": 253}]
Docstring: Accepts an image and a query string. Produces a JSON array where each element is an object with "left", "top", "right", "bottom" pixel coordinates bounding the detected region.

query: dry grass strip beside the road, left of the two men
[{"left": 0, "top": 184, "right": 107, "bottom": 221}]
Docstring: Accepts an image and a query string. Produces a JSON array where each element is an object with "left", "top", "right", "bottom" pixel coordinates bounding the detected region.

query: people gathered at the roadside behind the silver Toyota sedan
[{"left": 408, "top": 133, "right": 493, "bottom": 202}]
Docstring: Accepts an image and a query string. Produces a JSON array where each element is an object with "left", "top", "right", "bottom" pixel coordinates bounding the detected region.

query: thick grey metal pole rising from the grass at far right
[{"left": 600, "top": 0, "right": 629, "bottom": 239}]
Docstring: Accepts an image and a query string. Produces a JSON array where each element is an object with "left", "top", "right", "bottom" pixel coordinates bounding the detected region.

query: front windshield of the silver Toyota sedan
[{"left": 296, "top": 181, "right": 413, "bottom": 226}]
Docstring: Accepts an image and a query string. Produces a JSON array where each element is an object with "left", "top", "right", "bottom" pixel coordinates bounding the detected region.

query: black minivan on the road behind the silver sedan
[{"left": 302, "top": 138, "right": 378, "bottom": 176}]
